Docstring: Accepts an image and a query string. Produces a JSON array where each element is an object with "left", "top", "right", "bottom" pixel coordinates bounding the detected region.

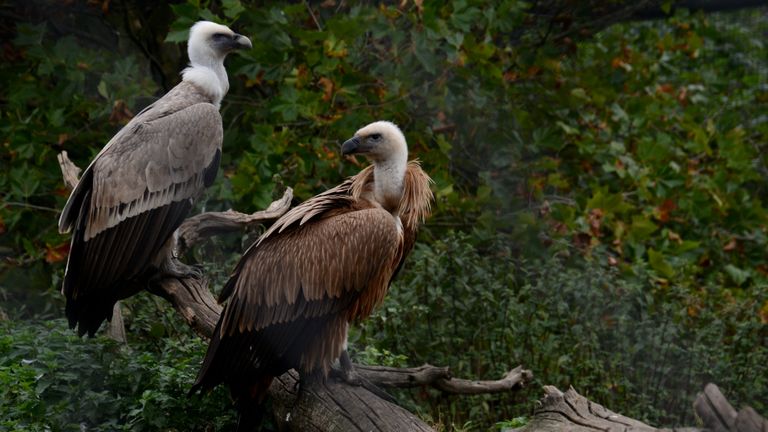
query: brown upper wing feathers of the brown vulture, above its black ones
[{"left": 221, "top": 207, "right": 402, "bottom": 335}]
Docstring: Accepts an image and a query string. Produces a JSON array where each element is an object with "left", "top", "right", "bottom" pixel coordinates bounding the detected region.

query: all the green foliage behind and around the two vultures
[{"left": 0, "top": 0, "right": 768, "bottom": 431}]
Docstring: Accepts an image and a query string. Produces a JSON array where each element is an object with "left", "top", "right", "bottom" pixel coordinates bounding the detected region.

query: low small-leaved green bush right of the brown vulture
[{"left": 353, "top": 234, "right": 768, "bottom": 429}]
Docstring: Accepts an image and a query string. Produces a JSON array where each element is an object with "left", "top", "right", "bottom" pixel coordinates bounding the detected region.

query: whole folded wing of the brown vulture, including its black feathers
[{"left": 193, "top": 204, "right": 402, "bottom": 396}]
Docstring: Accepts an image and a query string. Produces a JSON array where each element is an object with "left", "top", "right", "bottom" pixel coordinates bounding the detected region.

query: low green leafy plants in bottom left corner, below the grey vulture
[{"left": 0, "top": 319, "right": 234, "bottom": 431}]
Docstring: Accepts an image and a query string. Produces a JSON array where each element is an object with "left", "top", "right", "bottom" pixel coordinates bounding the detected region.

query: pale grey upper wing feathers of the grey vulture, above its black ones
[{"left": 85, "top": 103, "right": 223, "bottom": 240}]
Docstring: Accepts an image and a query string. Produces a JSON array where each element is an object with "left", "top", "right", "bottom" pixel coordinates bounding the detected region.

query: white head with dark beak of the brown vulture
[{"left": 341, "top": 121, "right": 408, "bottom": 165}]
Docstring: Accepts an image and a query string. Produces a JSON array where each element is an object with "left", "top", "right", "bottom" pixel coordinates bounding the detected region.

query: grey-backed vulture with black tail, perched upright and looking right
[{"left": 59, "top": 21, "right": 251, "bottom": 336}]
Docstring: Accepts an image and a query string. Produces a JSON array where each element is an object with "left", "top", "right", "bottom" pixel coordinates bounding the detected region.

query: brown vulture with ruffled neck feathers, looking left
[{"left": 192, "top": 121, "right": 433, "bottom": 429}]
